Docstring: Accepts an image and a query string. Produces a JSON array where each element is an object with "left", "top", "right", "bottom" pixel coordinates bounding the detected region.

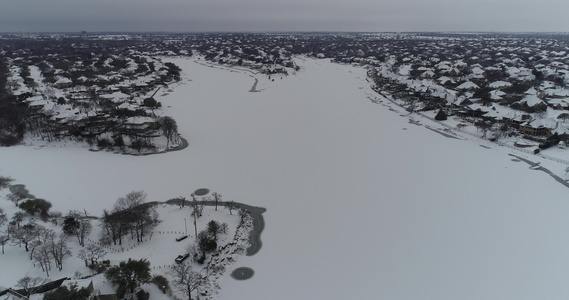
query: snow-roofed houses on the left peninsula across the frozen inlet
[{"left": 0, "top": 34, "right": 180, "bottom": 151}]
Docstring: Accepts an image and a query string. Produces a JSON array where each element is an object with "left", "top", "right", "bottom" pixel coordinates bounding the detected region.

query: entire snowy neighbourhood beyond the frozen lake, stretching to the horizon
[{"left": 0, "top": 33, "right": 569, "bottom": 148}]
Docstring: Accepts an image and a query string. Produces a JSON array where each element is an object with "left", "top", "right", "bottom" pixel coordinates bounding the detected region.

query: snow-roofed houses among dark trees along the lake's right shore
[{"left": 358, "top": 35, "right": 569, "bottom": 140}]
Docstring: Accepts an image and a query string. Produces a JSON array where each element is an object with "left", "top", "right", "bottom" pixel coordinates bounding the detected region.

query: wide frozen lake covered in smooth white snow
[{"left": 0, "top": 58, "right": 569, "bottom": 299}]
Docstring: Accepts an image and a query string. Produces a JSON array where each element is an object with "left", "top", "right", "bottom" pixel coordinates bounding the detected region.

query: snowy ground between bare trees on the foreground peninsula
[{"left": 0, "top": 198, "right": 243, "bottom": 300}]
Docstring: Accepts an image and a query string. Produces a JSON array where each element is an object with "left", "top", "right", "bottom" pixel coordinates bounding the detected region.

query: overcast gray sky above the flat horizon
[{"left": 0, "top": 0, "right": 569, "bottom": 32}]
